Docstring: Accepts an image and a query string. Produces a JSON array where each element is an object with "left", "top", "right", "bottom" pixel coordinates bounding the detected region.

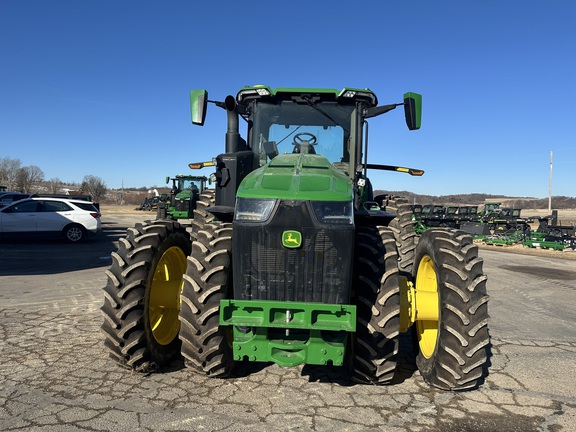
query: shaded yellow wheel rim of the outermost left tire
[{"left": 148, "top": 246, "right": 186, "bottom": 345}]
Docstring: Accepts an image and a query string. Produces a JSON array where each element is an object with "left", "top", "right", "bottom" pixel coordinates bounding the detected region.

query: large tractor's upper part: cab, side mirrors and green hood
[{"left": 191, "top": 86, "right": 421, "bottom": 220}]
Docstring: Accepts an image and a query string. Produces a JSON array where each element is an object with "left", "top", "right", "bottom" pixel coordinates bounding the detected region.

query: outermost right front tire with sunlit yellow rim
[{"left": 413, "top": 229, "right": 490, "bottom": 390}]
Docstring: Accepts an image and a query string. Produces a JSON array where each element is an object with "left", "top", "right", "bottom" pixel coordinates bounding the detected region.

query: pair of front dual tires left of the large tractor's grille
[{"left": 101, "top": 215, "right": 234, "bottom": 376}]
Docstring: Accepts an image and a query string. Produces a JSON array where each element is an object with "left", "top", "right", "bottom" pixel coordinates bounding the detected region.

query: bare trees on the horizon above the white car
[{"left": 0, "top": 157, "right": 108, "bottom": 202}]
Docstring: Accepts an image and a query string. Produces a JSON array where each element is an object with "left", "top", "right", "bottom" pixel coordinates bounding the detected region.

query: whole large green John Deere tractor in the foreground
[{"left": 102, "top": 86, "right": 490, "bottom": 390}]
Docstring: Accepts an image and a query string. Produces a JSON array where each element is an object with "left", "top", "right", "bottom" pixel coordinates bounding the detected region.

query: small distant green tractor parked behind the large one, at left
[{"left": 158, "top": 173, "right": 214, "bottom": 220}]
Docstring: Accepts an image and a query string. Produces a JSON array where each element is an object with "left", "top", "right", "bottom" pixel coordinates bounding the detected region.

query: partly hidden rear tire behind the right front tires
[{"left": 377, "top": 195, "right": 418, "bottom": 277}]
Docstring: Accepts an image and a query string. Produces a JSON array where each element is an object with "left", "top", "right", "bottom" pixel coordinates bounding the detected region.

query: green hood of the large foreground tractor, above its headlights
[{"left": 237, "top": 153, "right": 353, "bottom": 201}]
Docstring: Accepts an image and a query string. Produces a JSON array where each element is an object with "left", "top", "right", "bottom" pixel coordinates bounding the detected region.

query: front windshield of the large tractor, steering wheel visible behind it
[{"left": 252, "top": 101, "right": 355, "bottom": 165}]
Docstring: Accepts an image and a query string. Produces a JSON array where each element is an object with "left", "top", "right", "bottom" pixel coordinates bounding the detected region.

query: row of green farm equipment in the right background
[{"left": 412, "top": 202, "right": 576, "bottom": 250}]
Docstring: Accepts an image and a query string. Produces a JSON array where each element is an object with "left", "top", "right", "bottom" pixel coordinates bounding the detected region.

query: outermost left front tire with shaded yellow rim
[{"left": 101, "top": 220, "right": 191, "bottom": 372}]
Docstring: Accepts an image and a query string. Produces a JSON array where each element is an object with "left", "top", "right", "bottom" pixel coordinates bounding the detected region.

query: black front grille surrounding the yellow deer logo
[{"left": 233, "top": 201, "right": 354, "bottom": 304}]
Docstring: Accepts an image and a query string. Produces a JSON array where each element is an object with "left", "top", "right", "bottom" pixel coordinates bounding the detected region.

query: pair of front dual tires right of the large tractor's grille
[{"left": 352, "top": 227, "right": 490, "bottom": 390}]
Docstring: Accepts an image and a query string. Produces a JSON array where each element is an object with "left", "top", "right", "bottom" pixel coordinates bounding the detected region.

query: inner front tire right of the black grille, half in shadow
[{"left": 351, "top": 227, "right": 400, "bottom": 384}]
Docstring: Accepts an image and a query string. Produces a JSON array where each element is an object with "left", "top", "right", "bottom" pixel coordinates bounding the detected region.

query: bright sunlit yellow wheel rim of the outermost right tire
[{"left": 416, "top": 255, "right": 439, "bottom": 358}]
